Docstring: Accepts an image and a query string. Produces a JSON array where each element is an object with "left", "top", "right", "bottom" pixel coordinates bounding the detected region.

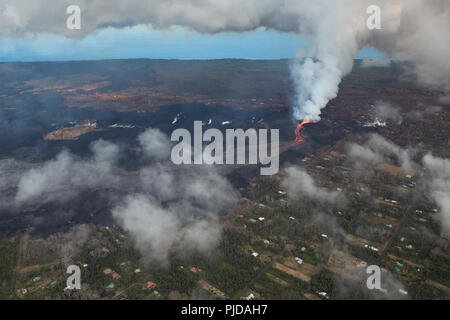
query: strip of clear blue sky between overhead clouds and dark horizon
[{"left": 0, "top": 25, "right": 385, "bottom": 61}]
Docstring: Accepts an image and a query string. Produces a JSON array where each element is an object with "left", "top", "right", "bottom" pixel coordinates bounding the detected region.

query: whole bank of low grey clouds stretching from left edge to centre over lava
[{"left": 0, "top": 129, "right": 239, "bottom": 264}]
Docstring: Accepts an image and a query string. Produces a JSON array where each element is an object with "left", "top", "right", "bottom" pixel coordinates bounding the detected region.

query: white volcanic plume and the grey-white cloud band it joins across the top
[{"left": 0, "top": 0, "right": 450, "bottom": 121}]
